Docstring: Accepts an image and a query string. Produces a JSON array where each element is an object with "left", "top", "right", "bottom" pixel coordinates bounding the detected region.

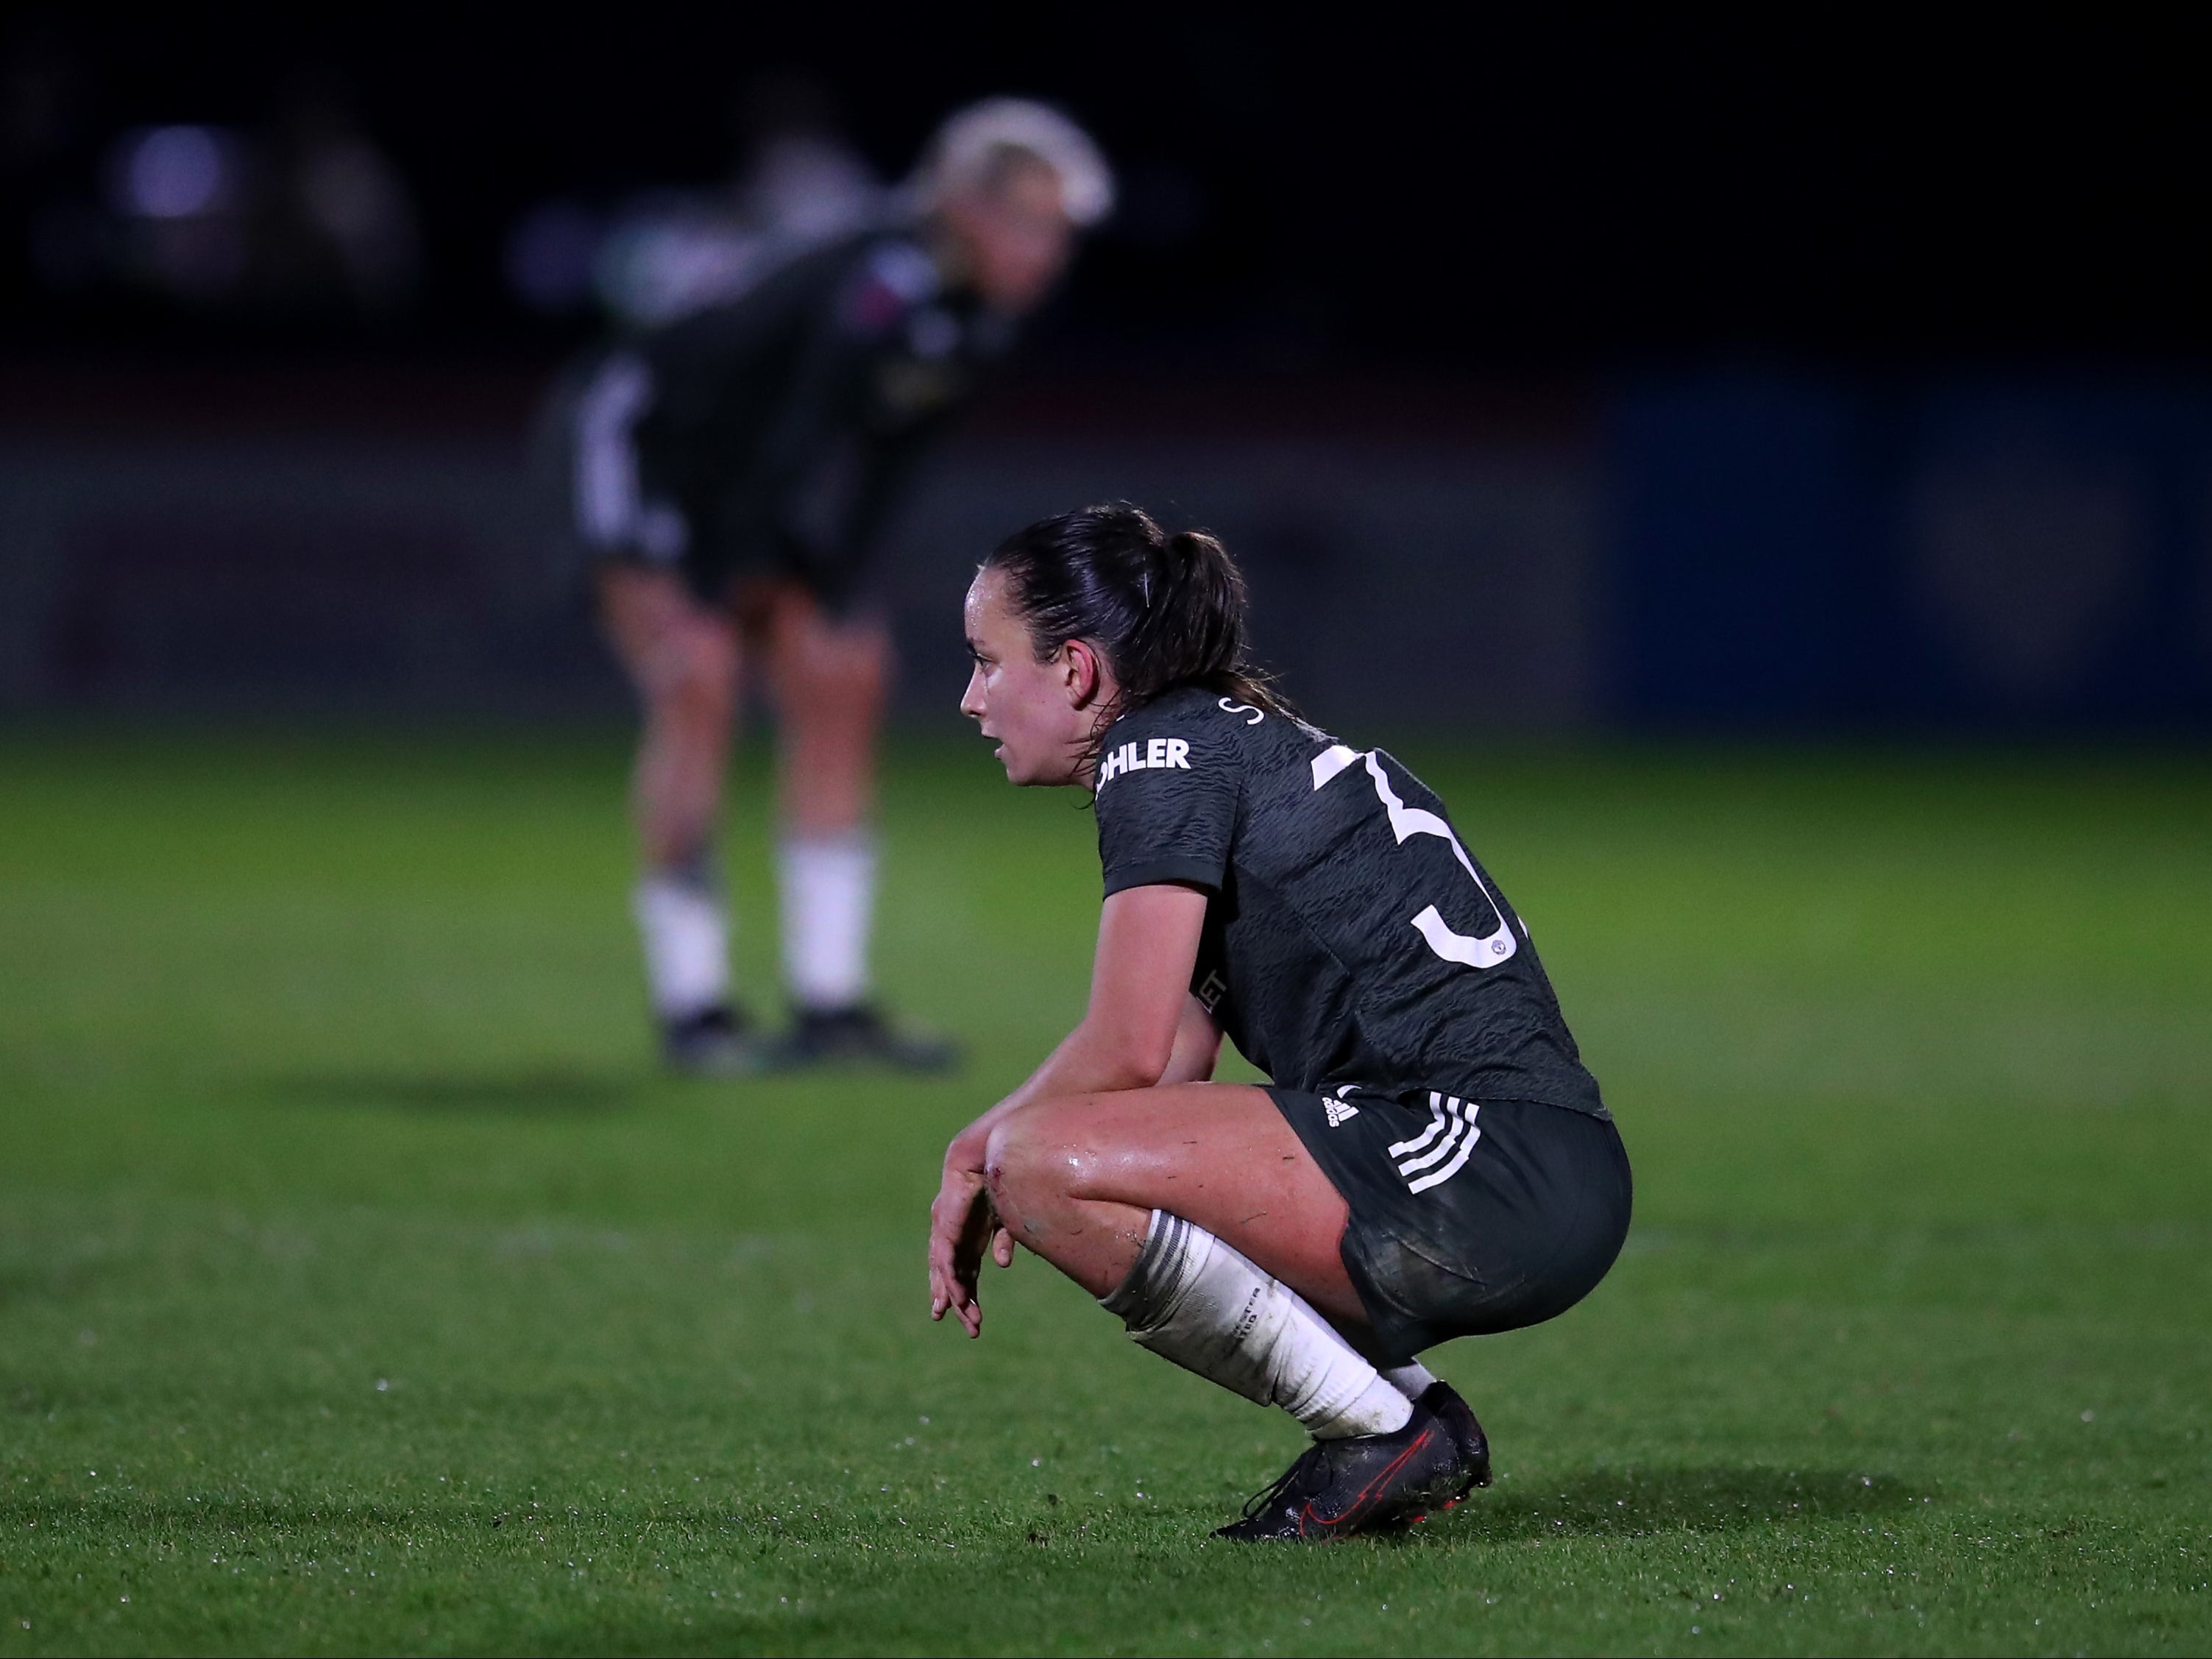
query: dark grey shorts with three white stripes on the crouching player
[{"left": 1267, "top": 1086, "right": 1632, "bottom": 1362}]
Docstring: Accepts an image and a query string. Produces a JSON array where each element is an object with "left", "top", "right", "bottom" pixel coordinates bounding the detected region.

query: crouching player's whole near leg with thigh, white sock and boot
[{"left": 985, "top": 1084, "right": 1489, "bottom": 1540}]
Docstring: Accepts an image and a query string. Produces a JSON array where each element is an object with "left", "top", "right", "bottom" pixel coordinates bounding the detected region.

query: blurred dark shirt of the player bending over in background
[{"left": 628, "top": 230, "right": 1013, "bottom": 597}]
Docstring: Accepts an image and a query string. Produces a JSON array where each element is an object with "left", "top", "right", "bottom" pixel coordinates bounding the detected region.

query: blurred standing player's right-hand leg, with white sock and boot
[{"left": 741, "top": 581, "right": 956, "bottom": 1071}]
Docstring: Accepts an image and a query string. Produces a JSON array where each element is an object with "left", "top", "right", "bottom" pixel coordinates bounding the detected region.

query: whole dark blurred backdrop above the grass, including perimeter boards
[{"left": 0, "top": 7, "right": 2212, "bottom": 735}]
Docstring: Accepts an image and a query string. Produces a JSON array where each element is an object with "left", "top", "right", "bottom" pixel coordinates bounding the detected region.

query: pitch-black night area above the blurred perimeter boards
[{"left": 7, "top": 7, "right": 2212, "bottom": 372}]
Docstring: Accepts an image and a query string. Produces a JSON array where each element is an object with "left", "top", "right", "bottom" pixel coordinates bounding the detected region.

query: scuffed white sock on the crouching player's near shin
[{"left": 1099, "top": 1210, "right": 1414, "bottom": 1440}]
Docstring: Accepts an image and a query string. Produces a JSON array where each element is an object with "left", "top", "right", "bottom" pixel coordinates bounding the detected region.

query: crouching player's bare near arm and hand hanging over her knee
[{"left": 929, "top": 885, "right": 1221, "bottom": 1336}]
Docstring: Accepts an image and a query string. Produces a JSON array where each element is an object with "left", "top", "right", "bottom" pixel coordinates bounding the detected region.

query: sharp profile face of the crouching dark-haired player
[{"left": 960, "top": 570, "right": 1110, "bottom": 785}]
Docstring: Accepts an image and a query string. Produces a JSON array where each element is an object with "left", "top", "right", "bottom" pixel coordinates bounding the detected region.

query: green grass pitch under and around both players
[{"left": 0, "top": 730, "right": 2212, "bottom": 1655}]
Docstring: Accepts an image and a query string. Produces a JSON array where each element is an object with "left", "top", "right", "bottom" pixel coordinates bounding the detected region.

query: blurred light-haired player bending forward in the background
[{"left": 546, "top": 99, "right": 1113, "bottom": 1073}]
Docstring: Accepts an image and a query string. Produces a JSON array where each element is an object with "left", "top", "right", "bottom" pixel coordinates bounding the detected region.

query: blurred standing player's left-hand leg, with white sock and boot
[{"left": 600, "top": 564, "right": 756, "bottom": 1071}]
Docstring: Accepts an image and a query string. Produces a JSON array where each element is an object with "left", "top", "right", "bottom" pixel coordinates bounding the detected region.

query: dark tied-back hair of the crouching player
[{"left": 982, "top": 502, "right": 1292, "bottom": 743}]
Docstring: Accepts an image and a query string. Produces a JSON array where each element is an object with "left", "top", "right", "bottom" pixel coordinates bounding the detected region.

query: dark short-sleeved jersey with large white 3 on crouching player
[{"left": 1095, "top": 688, "right": 1608, "bottom": 1117}]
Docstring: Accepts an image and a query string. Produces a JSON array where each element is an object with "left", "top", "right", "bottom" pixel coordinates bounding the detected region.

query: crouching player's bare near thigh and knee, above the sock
[{"left": 991, "top": 1084, "right": 1361, "bottom": 1316}]
